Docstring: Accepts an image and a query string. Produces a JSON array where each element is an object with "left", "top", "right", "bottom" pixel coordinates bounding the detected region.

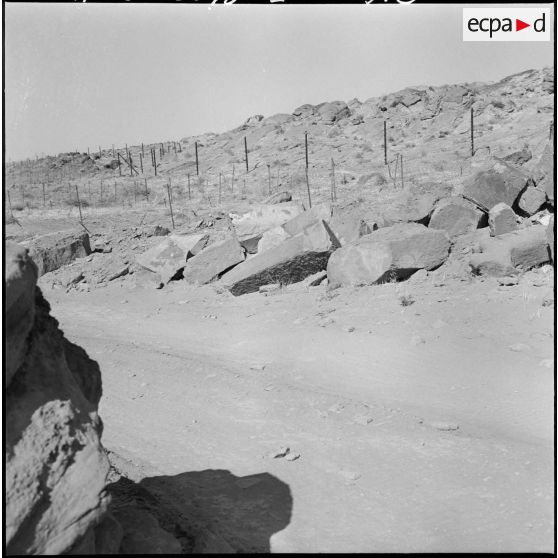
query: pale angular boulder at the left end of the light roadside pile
[{"left": 136, "top": 234, "right": 209, "bottom": 283}]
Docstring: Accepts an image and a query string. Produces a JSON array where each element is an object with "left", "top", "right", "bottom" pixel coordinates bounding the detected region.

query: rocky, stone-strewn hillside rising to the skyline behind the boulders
[{"left": 6, "top": 68, "right": 554, "bottom": 217}]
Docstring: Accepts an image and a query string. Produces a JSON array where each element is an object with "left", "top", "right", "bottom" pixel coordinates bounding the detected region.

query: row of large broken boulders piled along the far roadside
[{"left": 137, "top": 150, "right": 554, "bottom": 295}]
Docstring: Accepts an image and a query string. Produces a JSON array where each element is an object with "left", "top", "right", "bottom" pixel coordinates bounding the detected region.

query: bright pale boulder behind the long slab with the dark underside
[{"left": 231, "top": 203, "right": 302, "bottom": 254}]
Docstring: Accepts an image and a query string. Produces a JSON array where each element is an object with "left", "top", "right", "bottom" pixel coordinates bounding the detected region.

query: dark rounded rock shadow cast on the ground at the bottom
[{"left": 107, "top": 470, "right": 293, "bottom": 553}]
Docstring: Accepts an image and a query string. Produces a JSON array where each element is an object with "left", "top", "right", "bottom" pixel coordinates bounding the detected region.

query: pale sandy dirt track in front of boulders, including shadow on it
[{"left": 39, "top": 245, "right": 554, "bottom": 552}]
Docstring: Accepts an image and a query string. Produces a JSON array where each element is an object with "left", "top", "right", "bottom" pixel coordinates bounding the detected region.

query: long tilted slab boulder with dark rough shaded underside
[{"left": 221, "top": 221, "right": 340, "bottom": 296}]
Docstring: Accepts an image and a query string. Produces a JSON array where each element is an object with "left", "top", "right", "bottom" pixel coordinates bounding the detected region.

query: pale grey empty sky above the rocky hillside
[{"left": 5, "top": 2, "right": 554, "bottom": 159}]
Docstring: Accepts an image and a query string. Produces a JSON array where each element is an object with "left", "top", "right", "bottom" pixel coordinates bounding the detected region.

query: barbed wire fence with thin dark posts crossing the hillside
[{"left": 4, "top": 107, "right": 554, "bottom": 230}]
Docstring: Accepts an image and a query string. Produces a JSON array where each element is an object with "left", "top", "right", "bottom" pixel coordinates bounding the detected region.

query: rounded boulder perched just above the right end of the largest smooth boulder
[{"left": 428, "top": 196, "right": 483, "bottom": 238}]
